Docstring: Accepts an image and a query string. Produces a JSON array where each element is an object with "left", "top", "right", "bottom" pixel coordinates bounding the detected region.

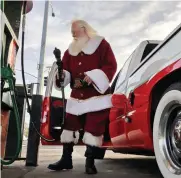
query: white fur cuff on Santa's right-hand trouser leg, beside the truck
[{"left": 82, "top": 132, "right": 103, "bottom": 147}]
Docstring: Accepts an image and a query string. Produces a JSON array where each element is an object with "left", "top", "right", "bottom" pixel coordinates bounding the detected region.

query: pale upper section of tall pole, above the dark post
[{"left": 36, "top": 0, "right": 49, "bottom": 95}]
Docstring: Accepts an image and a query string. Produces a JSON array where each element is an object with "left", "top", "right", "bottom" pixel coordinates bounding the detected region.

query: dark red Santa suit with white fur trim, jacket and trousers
[{"left": 55, "top": 36, "right": 117, "bottom": 147}]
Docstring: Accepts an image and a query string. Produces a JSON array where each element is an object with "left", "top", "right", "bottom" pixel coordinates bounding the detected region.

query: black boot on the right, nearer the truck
[{"left": 85, "top": 146, "right": 97, "bottom": 174}]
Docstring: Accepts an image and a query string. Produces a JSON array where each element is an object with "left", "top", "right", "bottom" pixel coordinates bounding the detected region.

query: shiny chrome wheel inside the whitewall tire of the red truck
[{"left": 159, "top": 101, "right": 181, "bottom": 175}]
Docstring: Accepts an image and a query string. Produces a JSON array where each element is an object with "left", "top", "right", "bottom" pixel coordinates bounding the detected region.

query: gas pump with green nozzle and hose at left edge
[{"left": 0, "top": 1, "right": 33, "bottom": 165}]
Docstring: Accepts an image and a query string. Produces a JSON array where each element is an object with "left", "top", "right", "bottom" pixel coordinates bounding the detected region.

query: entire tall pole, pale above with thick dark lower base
[{"left": 26, "top": 0, "right": 49, "bottom": 166}]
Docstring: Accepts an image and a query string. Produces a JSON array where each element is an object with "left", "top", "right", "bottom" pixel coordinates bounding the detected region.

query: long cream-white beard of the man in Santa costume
[{"left": 70, "top": 36, "right": 89, "bottom": 53}]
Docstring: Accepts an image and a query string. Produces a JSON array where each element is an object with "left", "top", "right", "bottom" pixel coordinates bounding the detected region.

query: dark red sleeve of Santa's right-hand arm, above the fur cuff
[{"left": 100, "top": 40, "right": 117, "bottom": 82}]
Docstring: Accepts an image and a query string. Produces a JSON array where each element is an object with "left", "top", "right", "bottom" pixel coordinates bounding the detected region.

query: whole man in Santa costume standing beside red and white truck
[{"left": 48, "top": 20, "right": 117, "bottom": 174}]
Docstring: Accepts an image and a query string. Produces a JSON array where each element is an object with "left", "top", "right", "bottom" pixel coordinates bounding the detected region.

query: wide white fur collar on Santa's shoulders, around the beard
[{"left": 68, "top": 36, "right": 104, "bottom": 56}]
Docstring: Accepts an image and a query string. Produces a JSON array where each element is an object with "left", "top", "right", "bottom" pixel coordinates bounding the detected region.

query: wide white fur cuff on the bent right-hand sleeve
[{"left": 85, "top": 69, "right": 109, "bottom": 94}]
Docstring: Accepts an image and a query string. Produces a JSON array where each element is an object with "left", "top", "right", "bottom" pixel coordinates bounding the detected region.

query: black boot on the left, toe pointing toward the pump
[{"left": 48, "top": 143, "right": 73, "bottom": 171}]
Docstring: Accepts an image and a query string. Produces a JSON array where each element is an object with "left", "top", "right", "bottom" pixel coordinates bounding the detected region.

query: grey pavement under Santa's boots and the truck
[{"left": 1, "top": 146, "right": 162, "bottom": 178}]
